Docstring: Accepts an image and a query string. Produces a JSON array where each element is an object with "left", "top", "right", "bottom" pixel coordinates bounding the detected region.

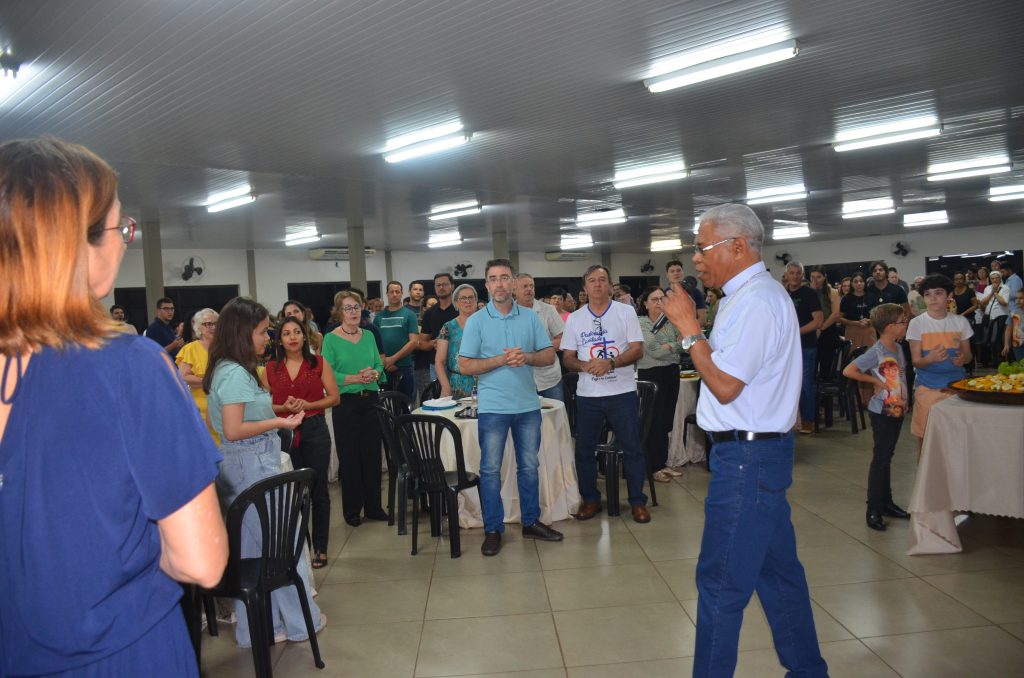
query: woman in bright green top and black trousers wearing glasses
[{"left": 323, "top": 291, "right": 387, "bottom": 526}]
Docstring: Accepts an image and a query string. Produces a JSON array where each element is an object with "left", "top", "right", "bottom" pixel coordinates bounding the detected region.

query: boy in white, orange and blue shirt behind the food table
[{"left": 906, "top": 274, "right": 974, "bottom": 458}]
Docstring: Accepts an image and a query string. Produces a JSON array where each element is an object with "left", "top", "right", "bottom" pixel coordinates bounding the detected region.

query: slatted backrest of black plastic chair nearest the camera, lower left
[{"left": 221, "top": 468, "right": 315, "bottom": 588}]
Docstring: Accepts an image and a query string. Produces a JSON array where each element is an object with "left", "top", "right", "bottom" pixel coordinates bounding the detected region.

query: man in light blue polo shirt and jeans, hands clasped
[{"left": 459, "top": 259, "right": 562, "bottom": 555}]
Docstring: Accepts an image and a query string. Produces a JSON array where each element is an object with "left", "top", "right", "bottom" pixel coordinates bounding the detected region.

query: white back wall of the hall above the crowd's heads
[{"left": 103, "top": 223, "right": 1024, "bottom": 319}]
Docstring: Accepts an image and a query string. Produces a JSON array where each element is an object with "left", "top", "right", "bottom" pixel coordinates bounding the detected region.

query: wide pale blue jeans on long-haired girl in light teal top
[{"left": 217, "top": 432, "right": 319, "bottom": 647}]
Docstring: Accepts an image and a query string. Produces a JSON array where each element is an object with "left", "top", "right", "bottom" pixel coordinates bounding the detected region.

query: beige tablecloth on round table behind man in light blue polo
[{"left": 415, "top": 398, "right": 580, "bottom": 527}]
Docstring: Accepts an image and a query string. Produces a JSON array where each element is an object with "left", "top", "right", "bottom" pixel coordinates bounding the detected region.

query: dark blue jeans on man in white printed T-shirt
[{"left": 577, "top": 391, "right": 647, "bottom": 506}]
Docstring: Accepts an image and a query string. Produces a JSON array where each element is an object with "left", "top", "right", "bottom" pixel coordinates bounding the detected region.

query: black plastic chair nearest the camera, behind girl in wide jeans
[{"left": 203, "top": 468, "right": 325, "bottom": 678}]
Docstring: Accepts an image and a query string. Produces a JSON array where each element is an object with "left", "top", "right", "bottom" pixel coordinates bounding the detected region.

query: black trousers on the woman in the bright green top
[{"left": 331, "top": 393, "right": 384, "bottom": 518}]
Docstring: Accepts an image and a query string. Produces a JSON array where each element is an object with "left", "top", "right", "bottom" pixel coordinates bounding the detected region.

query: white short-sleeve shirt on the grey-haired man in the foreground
[{"left": 697, "top": 261, "right": 803, "bottom": 433}]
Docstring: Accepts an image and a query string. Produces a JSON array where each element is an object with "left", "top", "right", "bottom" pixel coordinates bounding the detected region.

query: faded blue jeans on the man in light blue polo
[{"left": 477, "top": 410, "right": 541, "bottom": 533}]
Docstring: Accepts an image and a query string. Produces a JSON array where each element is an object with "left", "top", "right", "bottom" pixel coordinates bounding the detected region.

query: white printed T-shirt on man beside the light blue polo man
[{"left": 561, "top": 301, "right": 643, "bottom": 397}]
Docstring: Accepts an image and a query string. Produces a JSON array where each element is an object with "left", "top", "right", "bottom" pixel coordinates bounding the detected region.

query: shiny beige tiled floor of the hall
[{"left": 197, "top": 422, "right": 1024, "bottom": 678}]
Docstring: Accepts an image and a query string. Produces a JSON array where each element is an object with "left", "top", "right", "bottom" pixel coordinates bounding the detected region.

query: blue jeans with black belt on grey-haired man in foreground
[{"left": 693, "top": 433, "right": 828, "bottom": 678}]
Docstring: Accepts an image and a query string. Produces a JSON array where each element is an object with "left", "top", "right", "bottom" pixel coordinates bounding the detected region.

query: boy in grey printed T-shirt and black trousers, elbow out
[{"left": 843, "top": 304, "right": 909, "bottom": 532}]
